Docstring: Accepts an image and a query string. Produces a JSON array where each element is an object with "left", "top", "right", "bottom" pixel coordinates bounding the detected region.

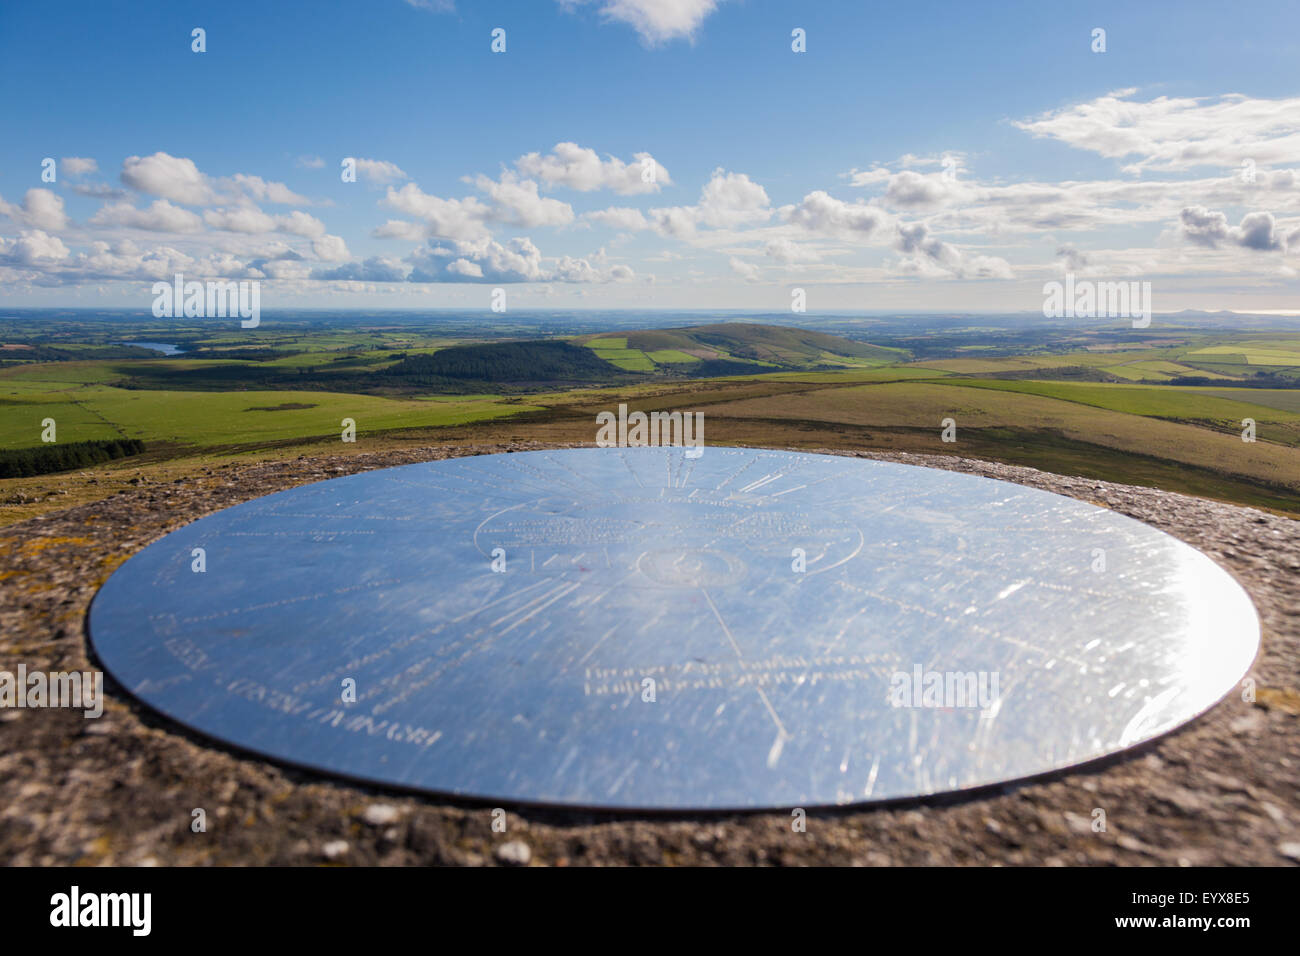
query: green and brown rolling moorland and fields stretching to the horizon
[{"left": 0, "top": 321, "right": 1300, "bottom": 523}]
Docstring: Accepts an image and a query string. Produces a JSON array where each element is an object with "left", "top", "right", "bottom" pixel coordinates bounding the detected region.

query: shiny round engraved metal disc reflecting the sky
[{"left": 90, "top": 447, "right": 1258, "bottom": 809}]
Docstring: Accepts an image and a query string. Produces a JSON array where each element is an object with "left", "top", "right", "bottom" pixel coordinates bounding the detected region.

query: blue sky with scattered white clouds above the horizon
[{"left": 0, "top": 0, "right": 1300, "bottom": 311}]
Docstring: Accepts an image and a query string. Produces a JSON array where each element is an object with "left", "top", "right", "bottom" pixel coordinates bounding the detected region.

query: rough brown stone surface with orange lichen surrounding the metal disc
[{"left": 0, "top": 442, "right": 1300, "bottom": 866}]
